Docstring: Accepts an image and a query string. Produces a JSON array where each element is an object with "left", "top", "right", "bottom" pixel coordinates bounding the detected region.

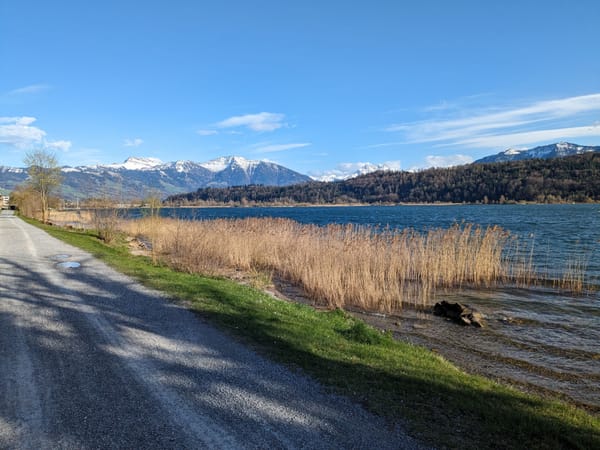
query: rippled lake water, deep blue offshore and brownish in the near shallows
[{"left": 130, "top": 204, "right": 600, "bottom": 413}]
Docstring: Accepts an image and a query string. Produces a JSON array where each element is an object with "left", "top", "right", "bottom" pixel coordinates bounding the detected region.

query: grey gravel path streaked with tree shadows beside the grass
[{"left": 0, "top": 212, "right": 420, "bottom": 449}]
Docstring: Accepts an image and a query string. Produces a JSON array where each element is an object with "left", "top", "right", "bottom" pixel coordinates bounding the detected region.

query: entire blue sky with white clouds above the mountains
[{"left": 0, "top": 0, "right": 600, "bottom": 176}]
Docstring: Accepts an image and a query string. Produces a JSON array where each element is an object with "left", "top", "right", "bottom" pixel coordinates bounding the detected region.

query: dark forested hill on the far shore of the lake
[{"left": 166, "top": 152, "right": 600, "bottom": 206}]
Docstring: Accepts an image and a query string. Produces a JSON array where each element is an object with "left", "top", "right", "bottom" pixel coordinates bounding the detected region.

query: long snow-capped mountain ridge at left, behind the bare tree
[{"left": 0, "top": 156, "right": 310, "bottom": 200}]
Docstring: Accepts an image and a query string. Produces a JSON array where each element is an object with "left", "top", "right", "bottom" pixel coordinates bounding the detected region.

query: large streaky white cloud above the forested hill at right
[{"left": 385, "top": 94, "right": 600, "bottom": 148}]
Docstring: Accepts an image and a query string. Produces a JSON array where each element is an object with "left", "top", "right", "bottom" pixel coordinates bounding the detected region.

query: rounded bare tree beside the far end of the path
[{"left": 24, "top": 150, "right": 62, "bottom": 222}]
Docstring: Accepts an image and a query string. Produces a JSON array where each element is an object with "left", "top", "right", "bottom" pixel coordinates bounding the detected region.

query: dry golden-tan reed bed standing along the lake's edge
[{"left": 120, "top": 217, "right": 521, "bottom": 313}]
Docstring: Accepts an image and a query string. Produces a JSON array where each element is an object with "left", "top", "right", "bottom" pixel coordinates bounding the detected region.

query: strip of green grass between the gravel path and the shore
[{"left": 31, "top": 217, "right": 600, "bottom": 449}]
